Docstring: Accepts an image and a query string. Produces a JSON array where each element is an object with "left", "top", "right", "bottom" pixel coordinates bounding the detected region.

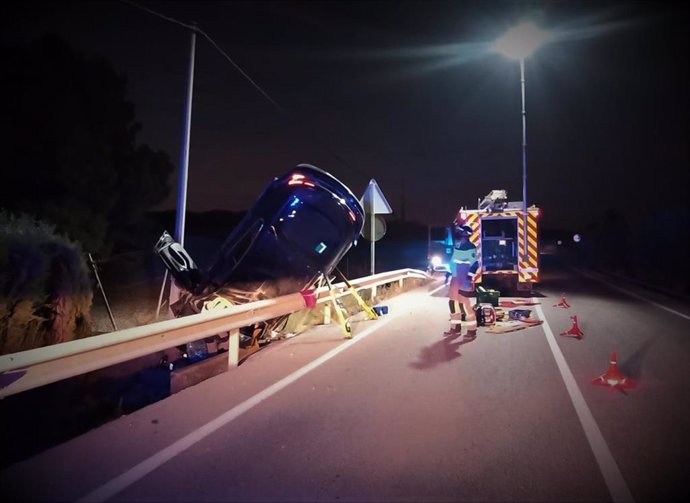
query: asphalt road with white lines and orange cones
[{"left": 0, "top": 271, "right": 690, "bottom": 502}]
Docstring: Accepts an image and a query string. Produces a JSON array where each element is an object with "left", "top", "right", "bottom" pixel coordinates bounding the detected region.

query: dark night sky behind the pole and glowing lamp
[{"left": 1, "top": 1, "right": 690, "bottom": 230}]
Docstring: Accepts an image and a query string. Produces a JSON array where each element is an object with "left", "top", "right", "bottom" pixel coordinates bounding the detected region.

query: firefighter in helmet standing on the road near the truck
[{"left": 444, "top": 223, "right": 479, "bottom": 341}]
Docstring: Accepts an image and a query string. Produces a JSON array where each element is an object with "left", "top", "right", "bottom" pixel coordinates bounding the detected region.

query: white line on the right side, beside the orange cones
[{"left": 532, "top": 299, "right": 635, "bottom": 502}]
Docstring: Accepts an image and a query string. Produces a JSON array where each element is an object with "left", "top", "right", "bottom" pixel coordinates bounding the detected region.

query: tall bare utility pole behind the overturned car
[{"left": 164, "top": 23, "right": 196, "bottom": 306}]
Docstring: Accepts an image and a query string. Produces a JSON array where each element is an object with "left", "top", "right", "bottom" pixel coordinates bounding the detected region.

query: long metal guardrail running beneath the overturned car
[{"left": 0, "top": 269, "right": 429, "bottom": 398}]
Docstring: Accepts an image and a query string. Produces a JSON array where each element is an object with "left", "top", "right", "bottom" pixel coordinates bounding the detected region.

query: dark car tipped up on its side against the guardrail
[{"left": 154, "top": 164, "right": 364, "bottom": 346}]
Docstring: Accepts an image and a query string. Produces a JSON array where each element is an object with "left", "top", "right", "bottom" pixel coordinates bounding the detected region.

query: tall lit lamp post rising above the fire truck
[{"left": 494, "top": 21, "right": 548, "bottom": 258}]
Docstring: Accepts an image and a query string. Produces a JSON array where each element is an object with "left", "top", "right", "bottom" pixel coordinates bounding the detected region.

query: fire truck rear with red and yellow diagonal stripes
[{"left": 446, "top": 190, "right": 540, "bottom": 291}]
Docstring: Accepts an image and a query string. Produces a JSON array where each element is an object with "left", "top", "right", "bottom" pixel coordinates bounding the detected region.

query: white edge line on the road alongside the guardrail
[{"left": 77, "top": 314, "right": 395, "bottom": 502}]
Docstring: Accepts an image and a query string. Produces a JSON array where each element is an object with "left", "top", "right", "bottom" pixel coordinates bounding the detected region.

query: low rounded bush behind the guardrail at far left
[{"left": 0, "top": 211, "right": 93, "bottom": 354}]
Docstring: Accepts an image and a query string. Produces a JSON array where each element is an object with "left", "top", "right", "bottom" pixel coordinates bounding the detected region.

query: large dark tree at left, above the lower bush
[{"left": 0, "top": 32, "right": 173, "bottom": 256}]
